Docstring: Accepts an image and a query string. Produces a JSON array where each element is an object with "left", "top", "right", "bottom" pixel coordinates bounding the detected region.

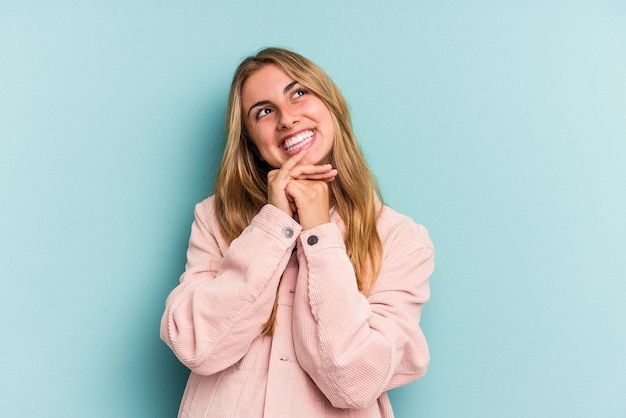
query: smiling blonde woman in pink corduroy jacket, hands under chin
[{"left": 161, "top": 48, "right": 434, "bottom": 418}]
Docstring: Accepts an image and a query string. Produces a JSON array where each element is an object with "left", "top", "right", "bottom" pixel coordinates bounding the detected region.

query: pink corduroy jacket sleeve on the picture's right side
[{"left": 293, "top": 218, "right": 434, "bottom": 408}]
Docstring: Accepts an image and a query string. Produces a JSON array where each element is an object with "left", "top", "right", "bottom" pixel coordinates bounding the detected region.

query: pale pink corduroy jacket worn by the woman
[{"left": 161, "top": 197, "right": 434, "bottom": 418}]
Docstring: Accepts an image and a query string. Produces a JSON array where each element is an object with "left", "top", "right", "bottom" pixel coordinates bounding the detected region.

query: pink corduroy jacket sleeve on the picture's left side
[{"left": 161, "top": 199, "right": 301, "bottom": 375}]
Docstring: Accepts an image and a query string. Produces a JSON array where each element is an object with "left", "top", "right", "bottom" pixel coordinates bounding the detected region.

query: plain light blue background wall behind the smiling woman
[{"left": 0, "top": 0, "right": 626, "bottom": 418}]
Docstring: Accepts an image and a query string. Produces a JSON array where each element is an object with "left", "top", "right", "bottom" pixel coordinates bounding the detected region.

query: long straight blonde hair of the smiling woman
[{"left": 215, "top": 48, "right": 382, "bottom": 334}]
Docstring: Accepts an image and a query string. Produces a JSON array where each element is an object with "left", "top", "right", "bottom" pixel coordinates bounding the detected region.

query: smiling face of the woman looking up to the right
[{"left": 241, "top": 64, "right": 335, "bottom": 168}]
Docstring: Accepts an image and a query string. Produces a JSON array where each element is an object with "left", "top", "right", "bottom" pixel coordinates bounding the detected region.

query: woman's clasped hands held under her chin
[{"left": 267, "top": 151, "right": 337, "bottom": 230}]
